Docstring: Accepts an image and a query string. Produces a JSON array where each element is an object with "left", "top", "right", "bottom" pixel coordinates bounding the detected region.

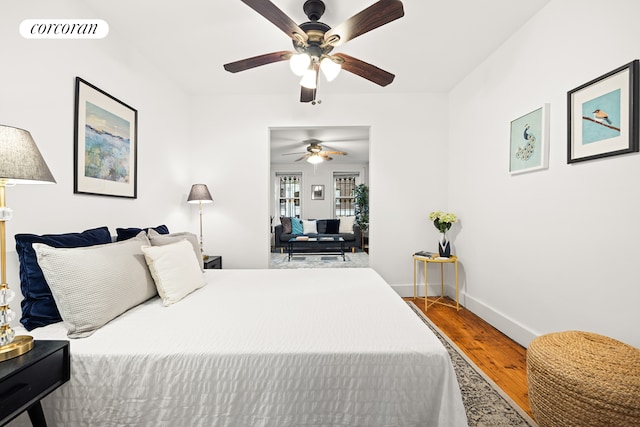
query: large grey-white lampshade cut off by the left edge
[{"left": 0, "top": 125, "right": 56, "bottom": 184}]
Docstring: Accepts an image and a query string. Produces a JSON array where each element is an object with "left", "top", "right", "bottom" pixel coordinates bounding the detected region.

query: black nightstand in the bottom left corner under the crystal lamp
[{"left": 0, "top": 340, "right": 71, "bottom": 427}]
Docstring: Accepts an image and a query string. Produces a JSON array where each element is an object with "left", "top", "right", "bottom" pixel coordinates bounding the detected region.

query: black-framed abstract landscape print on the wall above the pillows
[{"left": 73, "top": 77, "right": 138, "bottom": 199}]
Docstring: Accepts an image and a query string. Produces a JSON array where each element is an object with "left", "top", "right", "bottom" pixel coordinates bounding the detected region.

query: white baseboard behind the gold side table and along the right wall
[{"left": 391, "top": 284, "right": 540, "bottom": 347}]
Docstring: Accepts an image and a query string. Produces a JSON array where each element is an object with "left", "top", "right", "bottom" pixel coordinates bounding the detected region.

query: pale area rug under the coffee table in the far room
[{"left": 269, "top": 252, "right": 369, "bottom": 268}]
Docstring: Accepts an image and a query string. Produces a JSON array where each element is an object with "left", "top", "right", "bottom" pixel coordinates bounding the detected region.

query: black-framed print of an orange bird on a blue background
[{"left": 567, "top": 59, "right": 640, "bottom": 163}]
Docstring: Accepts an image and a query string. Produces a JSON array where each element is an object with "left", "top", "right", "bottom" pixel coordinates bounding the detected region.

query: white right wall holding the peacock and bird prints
[{"left": 448, "top": 0, "right": 640, "bottom": 346}]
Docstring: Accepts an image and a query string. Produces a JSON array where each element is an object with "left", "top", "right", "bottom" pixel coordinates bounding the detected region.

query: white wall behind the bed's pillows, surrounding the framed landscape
[{"left": 0, "top": 0, "right": 192, "bottom": 309}]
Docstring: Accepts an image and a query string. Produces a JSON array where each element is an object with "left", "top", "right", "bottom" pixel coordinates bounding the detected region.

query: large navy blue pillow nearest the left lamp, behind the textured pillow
[{"left": 15, "top": 227, "right": 111, "bottom": 331}]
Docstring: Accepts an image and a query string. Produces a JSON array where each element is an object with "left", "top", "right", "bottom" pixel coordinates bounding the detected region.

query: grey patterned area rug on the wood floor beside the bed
[{"left": 407, "top": 301, "right": 537, "bottom": 427}]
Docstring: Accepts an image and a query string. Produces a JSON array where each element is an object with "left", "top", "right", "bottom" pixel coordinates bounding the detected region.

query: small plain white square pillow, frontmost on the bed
[{"left": 142, "top": 239, "right": 204, "bottom": 306}]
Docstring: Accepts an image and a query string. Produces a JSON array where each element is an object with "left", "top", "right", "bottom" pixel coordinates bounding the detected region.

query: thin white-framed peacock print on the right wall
[{"left": 509, "top": 104, "right": 550, "bottom": 175}]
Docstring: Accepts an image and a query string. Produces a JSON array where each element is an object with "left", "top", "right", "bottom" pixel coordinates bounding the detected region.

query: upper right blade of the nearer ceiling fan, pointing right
[{"left": 324, "top": 0, "right": 404, "bottom": 46}]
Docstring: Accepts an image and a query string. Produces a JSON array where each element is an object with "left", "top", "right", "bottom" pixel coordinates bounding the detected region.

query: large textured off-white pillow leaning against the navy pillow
[{"left": 33, "top": 232, "right": 157, "bottom": 338}]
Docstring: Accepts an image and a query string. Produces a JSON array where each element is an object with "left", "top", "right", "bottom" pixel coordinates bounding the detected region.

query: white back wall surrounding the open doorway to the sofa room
[{"left": 192, "top": 94, "right": 447, "bottom": 286}]
